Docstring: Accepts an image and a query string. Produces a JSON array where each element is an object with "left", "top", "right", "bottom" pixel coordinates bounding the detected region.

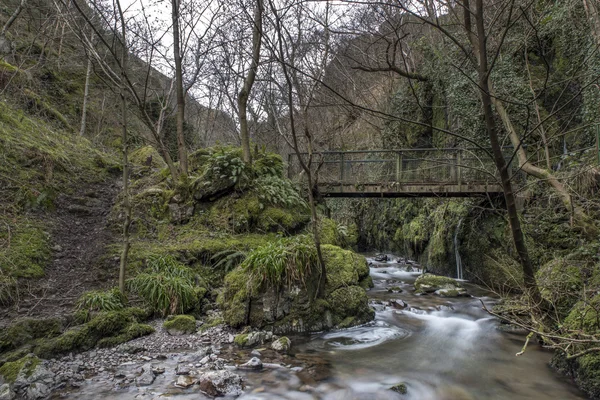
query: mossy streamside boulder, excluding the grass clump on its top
[{"left": 220, "top": 245, "right": 374, "bottom": 332}]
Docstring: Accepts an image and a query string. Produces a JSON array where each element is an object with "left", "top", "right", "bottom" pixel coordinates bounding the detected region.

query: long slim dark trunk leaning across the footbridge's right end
[{"left": 474, "top": 0, "right": 542, "bottom": 304}]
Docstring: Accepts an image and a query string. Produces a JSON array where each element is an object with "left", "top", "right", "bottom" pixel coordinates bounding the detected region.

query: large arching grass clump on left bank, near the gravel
[{"left": 127, "top": 255, "right": 198, "bottom": 316}]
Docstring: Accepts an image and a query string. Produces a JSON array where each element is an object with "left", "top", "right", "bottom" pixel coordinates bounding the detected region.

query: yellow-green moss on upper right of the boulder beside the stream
[{"left": 321, "top": 244, "right": 369, "bottom": 292}]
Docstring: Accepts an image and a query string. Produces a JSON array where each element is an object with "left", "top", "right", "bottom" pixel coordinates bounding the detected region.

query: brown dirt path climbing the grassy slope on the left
[{"left": 0, "top": 179, "right": 119, "bottom": 327}]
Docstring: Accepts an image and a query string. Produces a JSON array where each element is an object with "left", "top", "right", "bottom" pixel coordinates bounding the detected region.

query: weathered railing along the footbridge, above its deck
[{"left": 288, "top": 148, "right": 512, "bottom": 185}]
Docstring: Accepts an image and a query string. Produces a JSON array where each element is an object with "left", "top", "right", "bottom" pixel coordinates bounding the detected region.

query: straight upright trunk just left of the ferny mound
[{"left": 171, "top": 0, "right": 188, "bottom": 176}]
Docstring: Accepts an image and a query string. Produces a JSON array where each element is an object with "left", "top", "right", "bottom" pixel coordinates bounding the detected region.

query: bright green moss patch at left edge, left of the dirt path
[{"left": 0, "top": 217, "right": 51, "bottom": 278}]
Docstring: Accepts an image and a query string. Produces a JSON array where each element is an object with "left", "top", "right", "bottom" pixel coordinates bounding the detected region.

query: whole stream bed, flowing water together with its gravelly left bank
[{"left": 0, "top": 257, "right": 585, "bottom": 400}]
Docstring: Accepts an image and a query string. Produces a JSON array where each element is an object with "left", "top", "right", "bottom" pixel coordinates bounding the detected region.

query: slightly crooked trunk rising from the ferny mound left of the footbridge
[{"left": 238, "top": 0, "right": 263, "bottom": 163}]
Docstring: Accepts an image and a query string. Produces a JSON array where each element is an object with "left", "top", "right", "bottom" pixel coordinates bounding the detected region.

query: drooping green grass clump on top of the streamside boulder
[{"left": 241, "top": 236, "right": 317, "bottom": 287}]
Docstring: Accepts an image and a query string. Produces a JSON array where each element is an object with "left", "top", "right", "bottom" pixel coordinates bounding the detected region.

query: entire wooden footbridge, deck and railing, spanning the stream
[{"left": 288, "top": 149, "right": 511, "bottom": 197}]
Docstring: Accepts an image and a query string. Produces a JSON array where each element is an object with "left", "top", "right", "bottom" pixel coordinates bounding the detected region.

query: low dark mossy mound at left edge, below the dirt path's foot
[{"left": 0, "top": 318, "right": 63, "bottom": 352}]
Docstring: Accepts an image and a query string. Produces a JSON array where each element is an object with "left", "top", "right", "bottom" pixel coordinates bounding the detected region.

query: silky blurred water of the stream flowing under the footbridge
[{"left": 61, "top": 257, "right": 586, "bottom": 400}]
